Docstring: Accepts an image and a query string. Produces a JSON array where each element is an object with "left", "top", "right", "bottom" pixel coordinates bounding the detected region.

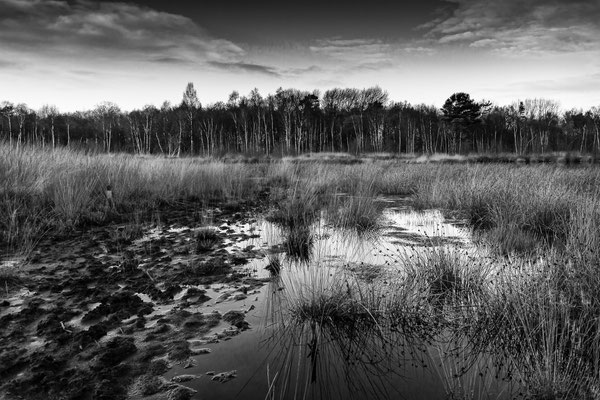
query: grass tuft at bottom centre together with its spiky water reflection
[{"left": 269, "top": 264, "right": 408, "bottom": 398}]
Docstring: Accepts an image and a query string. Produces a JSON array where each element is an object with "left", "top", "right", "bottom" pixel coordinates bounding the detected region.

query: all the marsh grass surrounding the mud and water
[{"left": 0, "top": 144, "right": 600, "bottom": 399}]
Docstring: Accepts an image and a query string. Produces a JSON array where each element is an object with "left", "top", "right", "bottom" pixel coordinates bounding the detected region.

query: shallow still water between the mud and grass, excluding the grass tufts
[{"left": 165, "top": 198, "right": 513, "bottom": 399}]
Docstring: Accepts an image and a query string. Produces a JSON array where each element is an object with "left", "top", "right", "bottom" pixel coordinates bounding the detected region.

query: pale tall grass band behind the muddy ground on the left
[{"left": 0, "top": 144, "right": 263, "bottom": 253}]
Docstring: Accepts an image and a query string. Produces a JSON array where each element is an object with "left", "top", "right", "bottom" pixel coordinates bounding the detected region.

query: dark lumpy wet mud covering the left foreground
[{"left": 0, "top": 203, "right": 274, "bottom": 399}]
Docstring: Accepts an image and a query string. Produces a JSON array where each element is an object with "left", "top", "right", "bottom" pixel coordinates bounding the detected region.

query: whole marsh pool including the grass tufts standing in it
[{"left": 165, "top": 199, "right": 515, "bottom": 399}]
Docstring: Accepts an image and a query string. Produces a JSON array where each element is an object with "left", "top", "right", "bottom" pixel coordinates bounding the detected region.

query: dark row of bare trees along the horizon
[{"left": 0, "top": 83, "right": 600, "bottom": 156}]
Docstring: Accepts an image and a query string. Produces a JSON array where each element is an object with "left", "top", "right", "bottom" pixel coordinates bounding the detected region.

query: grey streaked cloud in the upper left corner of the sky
[{"left": 0, "top": 0, "right": 245, "bottom": 63}]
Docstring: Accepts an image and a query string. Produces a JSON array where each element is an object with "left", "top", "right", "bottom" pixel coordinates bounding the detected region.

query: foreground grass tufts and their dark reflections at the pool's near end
[{"left": 264, "top": 256, "right": 512, "bottom": 399}]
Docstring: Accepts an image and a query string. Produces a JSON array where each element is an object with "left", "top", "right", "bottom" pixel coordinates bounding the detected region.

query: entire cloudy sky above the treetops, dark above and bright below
[{"left": 0, "top": 0, "right": 600, "bottom": 112}]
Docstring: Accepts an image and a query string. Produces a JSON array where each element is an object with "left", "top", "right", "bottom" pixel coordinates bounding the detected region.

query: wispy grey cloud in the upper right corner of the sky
[{"left": 420, "top": 0, "right": 600, "bottom": 55}]
